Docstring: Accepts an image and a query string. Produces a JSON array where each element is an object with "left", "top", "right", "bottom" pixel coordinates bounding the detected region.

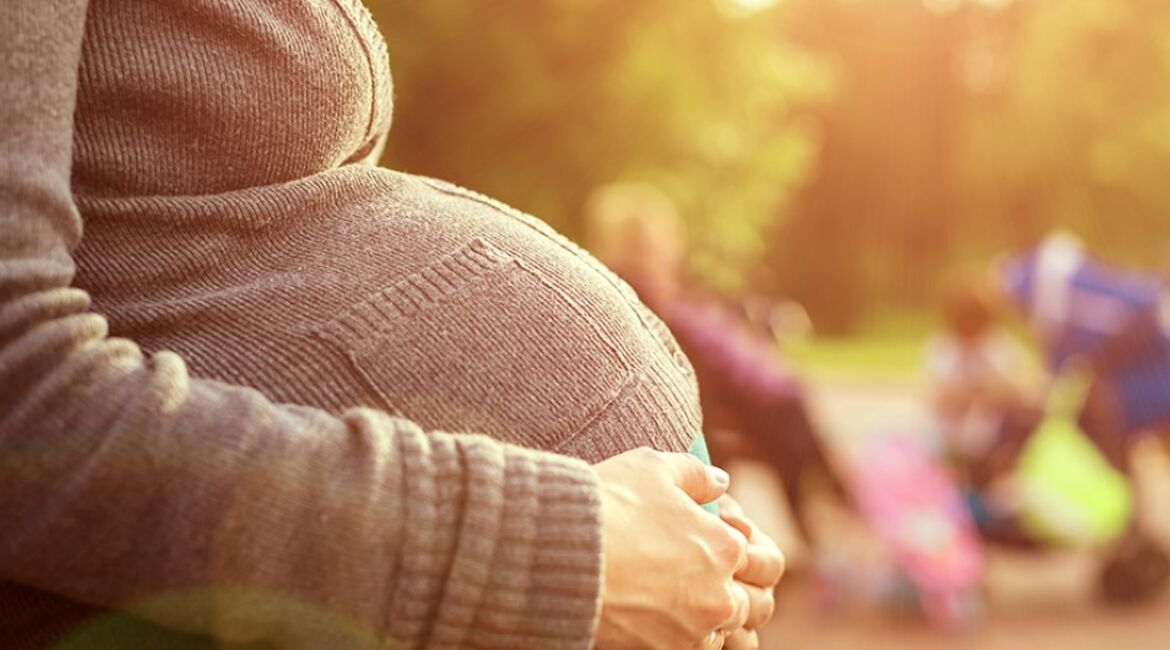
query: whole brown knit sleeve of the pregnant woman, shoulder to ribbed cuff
[{"left": 0, "top": 0, "right": 600, "bottom": 648}]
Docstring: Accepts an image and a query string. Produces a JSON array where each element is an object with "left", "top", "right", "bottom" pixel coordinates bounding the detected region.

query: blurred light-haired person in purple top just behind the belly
[{"left": 586, "top": 184, "right": 845, "bottom": 542}]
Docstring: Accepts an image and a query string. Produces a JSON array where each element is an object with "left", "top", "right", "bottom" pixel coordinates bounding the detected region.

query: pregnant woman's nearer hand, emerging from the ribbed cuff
[{"left": 594, "top": 448, "right": 751, "bottom": 650}]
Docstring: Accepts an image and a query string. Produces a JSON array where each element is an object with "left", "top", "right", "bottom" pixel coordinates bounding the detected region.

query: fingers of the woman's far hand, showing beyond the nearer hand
[{"left": 720, "top": 495, "right": 784, "bottom": 650}]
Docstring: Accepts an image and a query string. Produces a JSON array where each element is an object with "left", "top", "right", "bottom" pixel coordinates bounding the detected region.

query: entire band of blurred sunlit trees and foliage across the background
[{"left": 370, "top": 0, "right": 1170, "bottom": 332}]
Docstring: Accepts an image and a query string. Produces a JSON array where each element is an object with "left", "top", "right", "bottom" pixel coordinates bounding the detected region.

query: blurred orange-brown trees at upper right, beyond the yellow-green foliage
[{"left": 771, "top": 0, "right": 1170, "bottom": 332}]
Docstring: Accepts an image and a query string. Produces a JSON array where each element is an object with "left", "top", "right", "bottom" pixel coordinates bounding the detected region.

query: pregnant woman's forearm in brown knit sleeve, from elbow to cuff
[{"left": 0, "top": 343, "right": 600, "bottom": 646}]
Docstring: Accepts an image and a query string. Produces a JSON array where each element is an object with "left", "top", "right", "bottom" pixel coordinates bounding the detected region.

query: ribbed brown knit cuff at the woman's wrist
[{"left": 429, "top": 436, "right": 603, "bottom": 649}]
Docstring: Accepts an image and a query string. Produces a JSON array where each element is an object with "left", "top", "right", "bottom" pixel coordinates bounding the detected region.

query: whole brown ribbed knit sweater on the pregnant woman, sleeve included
[{"left": 0, "top": 0, "right": 700, "bottom": 649}]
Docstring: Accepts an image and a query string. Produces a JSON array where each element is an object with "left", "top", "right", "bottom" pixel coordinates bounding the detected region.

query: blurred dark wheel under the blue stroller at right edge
[{"left": 1099, "top": 533, "right": 1170, "bottom": 604}]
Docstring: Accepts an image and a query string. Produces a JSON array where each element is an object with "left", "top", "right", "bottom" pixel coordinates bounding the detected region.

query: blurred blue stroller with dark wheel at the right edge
[{"left": 998, "top": 231, "right": 1170, "bottom": 602}]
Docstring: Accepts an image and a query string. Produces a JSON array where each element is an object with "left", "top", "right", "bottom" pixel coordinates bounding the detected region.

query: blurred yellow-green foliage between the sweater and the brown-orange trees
[{"left": 369, "top": 0, "right": 831, "bottom": 291}]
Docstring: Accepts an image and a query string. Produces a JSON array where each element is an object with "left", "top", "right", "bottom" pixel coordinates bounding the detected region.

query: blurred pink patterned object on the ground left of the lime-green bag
[{"left": 854, "top": 435, "right": 984, "bottom": 627}]
